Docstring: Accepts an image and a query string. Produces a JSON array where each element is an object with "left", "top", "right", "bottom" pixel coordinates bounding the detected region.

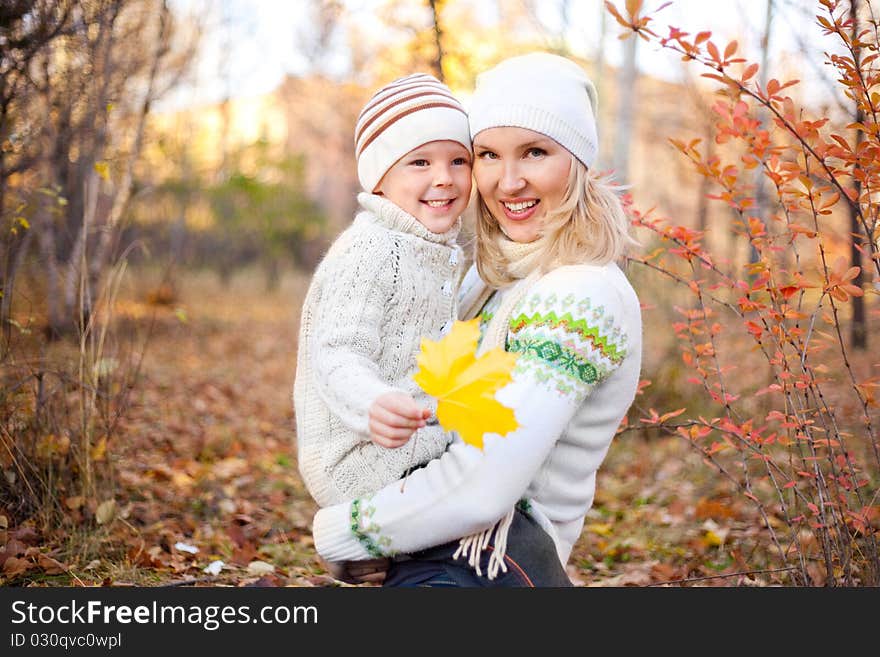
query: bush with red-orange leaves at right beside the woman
[{"left": 606, "top": 0, "right": 880, "bottom": 586}]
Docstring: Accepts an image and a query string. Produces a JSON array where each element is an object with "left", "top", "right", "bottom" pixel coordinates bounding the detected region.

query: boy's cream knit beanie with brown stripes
[{"left": 354, "top": 73, "right": 471, "bottom": 193}]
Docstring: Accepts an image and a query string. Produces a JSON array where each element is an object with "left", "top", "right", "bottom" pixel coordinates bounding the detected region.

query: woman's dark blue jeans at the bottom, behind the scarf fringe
[{"left": 382, "top": 509, "right": 571, "bottom": 588}]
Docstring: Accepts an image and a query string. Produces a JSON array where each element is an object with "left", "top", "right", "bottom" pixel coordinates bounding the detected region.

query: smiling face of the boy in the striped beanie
[{"left": 376, "top": 141, "right": 471, "bottom": 233}]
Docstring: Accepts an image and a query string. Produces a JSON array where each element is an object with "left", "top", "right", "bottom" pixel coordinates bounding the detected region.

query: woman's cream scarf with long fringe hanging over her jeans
[{"left": 452, "top": 235, "right": 545, "bottom": 579}]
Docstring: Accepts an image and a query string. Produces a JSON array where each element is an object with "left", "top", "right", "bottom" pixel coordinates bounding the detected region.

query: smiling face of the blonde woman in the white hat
[{"left": 474, "top": 128, "right": 572, "bottom": 242}]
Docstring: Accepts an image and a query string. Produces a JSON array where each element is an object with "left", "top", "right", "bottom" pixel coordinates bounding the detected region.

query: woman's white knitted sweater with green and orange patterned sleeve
[{"left": 313, "top": 264, "right": 642, "bottom": 565}]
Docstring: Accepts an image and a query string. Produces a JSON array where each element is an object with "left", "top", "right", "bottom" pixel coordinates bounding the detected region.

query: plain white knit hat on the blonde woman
[{"left": 469, "top": 52, "right": 599, "bottom": 167}]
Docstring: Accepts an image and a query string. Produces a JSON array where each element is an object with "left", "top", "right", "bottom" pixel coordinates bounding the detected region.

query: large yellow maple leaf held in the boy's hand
[{"left": 413, "top": 319, "right": 519, "bottom": 449}]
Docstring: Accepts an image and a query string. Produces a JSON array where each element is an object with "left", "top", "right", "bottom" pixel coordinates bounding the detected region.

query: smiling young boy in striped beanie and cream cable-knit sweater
[{"left": 293, "top": 74, "right": 471, "bottom": 506}]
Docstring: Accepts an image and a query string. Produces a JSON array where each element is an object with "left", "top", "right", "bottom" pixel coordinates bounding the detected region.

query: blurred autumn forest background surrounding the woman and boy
[{"left": 0, "top": 0, "right": 880, "bottom": 586}]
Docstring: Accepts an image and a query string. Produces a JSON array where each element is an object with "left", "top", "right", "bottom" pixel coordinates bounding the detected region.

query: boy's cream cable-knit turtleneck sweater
[{"left": 293, "top": 193, "right": 463, "bottom": 506}]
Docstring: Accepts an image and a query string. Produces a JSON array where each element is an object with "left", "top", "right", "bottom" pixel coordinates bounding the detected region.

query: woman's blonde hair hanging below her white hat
[{"left": 475, "top": 157, "right": 638, "bottom": 287}]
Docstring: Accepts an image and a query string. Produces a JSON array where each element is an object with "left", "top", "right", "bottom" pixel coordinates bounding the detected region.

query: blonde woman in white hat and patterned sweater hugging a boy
[{"left": 313, "top": 53, "right": 642, "bottom": 586}]
